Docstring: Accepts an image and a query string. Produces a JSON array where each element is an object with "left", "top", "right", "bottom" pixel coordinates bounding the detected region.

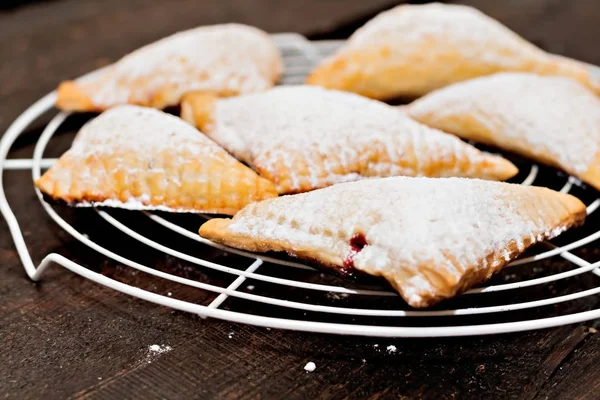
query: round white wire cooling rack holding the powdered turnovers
[{"left": 0, "top": 34, "right": 600, "bottom": 337}]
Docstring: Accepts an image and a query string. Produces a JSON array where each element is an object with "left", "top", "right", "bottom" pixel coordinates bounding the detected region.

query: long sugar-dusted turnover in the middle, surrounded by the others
[{"left": 181, "top": 86, "right": 517, "bottom": 193}]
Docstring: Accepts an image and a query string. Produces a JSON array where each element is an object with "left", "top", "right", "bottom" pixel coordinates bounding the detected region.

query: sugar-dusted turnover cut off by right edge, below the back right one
[{"left": 406, "top": 73, "right": 600, "bottom": 189}]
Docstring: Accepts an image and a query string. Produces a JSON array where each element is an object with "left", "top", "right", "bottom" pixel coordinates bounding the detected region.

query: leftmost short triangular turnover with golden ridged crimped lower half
[{"left": 35, "top": 106, "right": 277, "bottom": 214}]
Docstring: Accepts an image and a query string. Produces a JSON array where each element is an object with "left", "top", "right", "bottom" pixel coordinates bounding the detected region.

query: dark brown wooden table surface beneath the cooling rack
[{"left": 0, "top": 0, "right": 600, "bottom": 399}]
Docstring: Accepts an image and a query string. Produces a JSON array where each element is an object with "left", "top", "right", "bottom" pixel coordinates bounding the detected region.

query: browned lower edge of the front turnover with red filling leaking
[{"left": 199, "top": 196, "right": 587, "bottom": 308}]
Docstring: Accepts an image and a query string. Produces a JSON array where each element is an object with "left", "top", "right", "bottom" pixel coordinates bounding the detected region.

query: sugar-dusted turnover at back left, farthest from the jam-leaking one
[{"left": 56, "top": 24, "right": 282, "bottom": 111}]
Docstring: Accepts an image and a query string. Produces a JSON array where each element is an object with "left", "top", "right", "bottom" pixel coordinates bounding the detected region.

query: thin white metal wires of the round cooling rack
[{"left": 0, "top": 34, "right": 600, "bottom": 337}]
